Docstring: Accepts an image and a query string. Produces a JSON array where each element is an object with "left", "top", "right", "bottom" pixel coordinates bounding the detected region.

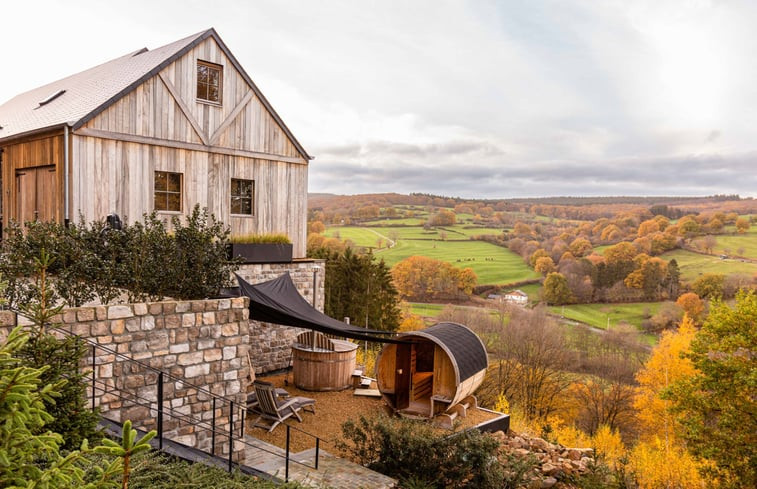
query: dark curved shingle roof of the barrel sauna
[{"left": 409, "top": 323, "right": 489, "bottom": 383}]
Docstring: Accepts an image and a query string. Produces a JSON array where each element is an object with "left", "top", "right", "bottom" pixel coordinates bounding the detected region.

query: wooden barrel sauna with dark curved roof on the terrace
[{"left": 376, "top": 323, "right": 489, "bottom": 418}]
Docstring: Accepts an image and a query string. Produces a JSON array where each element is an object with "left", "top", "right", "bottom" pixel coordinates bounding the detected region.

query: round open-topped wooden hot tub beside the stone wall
[{"left": 292, "top": 332, "right": 357, "bottom": 391}]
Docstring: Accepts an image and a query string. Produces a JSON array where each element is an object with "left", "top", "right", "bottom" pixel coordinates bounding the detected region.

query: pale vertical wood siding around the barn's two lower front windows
[{"left": 72, "top": 135, "right": 307, "bottom": 258}]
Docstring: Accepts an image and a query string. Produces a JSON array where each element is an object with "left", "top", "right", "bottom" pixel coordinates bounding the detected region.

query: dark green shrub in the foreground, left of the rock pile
[{"left": 339, "top": 416, "right": 533, "bottom": 489}]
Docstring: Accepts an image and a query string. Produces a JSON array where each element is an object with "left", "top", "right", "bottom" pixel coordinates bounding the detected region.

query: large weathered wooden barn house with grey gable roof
[{"left": 0, "top": 29, "right": 312, "bottom": 258}]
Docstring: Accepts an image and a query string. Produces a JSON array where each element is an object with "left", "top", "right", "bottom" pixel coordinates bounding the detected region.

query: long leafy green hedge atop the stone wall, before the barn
[{"left": 0, "top": 206, "right": 238, "bottom": 304}]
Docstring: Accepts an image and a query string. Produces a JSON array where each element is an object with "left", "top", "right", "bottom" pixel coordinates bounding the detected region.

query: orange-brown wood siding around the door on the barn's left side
[{"left": 2, "top": 130, "right": 64, "bottom": 227}]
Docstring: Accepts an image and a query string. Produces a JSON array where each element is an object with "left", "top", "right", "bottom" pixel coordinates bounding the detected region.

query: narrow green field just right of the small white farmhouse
[{"left": 549, "top": 302, "right": 662, "bottom": 329}]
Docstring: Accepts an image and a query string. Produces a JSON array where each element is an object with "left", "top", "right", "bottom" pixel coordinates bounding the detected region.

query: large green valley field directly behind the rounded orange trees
[{"left": 376, "top": 239, "right": 539, "bottom": 284}]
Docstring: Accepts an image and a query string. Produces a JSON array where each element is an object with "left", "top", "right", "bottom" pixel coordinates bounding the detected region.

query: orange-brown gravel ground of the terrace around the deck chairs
[{"left": 246, "top": 374, "right": 494, "bottom": 455}]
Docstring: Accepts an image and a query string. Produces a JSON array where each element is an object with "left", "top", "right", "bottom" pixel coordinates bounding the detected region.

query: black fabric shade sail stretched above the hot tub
[{"left": 235, "top": 272, "right": 405, "bottom": 343}]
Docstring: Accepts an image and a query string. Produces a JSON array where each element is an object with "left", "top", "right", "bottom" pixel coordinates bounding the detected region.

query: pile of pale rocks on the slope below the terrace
[{"left": 493, "top": 431, "right": 594, "bottom": 488}]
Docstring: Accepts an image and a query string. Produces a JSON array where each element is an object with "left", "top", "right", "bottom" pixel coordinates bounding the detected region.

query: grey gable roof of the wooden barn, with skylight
[{"left": 0, "top": 28, "right": 312, "bottom": 160}]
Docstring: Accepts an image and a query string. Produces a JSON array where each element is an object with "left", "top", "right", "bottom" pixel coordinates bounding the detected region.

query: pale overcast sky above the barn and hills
[{"left": 0, "top": 0, "right": 757, "bottom": 198}]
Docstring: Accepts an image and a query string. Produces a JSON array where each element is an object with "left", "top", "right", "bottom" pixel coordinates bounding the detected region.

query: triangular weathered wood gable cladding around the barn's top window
[{"left": 86, "top": 37, "right": 306, "bottom": 163}]
